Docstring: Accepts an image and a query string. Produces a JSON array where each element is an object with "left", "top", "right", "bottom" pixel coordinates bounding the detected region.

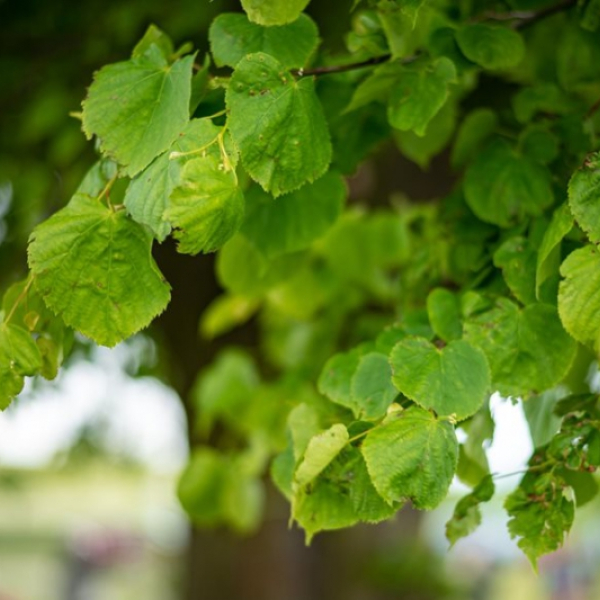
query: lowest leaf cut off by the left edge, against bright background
[{"left": 0, "top": 323, "right": 42, "bottom": 410}]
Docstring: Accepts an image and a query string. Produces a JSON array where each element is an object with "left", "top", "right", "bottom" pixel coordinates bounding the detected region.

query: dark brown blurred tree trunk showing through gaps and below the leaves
[{"left": 156, "top": 146, "right": 452, "bottom": 600}]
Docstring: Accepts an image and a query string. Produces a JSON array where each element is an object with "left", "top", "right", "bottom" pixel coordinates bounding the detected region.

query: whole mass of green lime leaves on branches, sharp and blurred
[{"left": 0, "top": 0, "right": 600, "bottom": 564}]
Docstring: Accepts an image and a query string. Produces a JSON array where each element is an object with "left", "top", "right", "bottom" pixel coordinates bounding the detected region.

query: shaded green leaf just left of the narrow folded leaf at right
[{"left": 494, "top": 236, "right": 537, "bottom": 304}]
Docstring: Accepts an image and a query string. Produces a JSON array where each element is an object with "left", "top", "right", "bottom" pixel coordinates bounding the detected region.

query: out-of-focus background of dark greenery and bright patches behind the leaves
[{"left": 0, "top": 0, "right": 600, "bottom": 600}]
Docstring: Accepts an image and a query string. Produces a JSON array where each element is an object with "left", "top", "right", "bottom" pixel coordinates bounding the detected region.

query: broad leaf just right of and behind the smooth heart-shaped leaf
[{"left": 464, "top": 298, "right": 577, "bottom": 397}]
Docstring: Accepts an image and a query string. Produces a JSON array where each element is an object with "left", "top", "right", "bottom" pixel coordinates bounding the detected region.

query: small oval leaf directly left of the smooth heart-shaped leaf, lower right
[{"left": 350, "top": 352, "right": 398, "bottom": 419}]
